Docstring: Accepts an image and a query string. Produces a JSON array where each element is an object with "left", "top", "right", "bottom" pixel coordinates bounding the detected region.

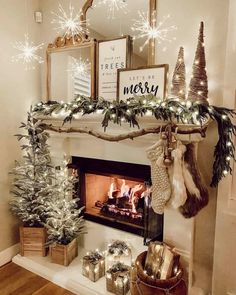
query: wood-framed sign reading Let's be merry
[{"left": 117, "top": 64, "right": 169, "bottom": 100}]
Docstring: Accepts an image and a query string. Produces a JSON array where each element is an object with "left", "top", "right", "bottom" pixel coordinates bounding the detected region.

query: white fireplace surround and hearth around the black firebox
[{"left": 13, "top": 114, "right": 205, "bottom": 295}]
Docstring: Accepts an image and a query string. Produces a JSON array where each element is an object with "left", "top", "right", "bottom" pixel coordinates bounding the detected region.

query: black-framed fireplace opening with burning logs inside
[{"left": 71, "top": 157, "right": 163, "bottom": 243}]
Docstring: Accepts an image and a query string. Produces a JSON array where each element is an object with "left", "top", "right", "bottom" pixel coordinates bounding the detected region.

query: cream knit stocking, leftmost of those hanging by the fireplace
[{"left": 147, "top": 140, "right": 171, "bottom": 214}]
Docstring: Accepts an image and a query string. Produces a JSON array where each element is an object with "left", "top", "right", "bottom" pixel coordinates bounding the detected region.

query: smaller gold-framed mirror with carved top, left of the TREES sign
[{"left": 47, "top": 37, "right": 96, "bottom": 102}]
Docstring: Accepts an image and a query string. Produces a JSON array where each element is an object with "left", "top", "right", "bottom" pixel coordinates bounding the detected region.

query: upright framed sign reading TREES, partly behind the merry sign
[{"left": 97, "top": 36, "right": 132, "bottom": 101}]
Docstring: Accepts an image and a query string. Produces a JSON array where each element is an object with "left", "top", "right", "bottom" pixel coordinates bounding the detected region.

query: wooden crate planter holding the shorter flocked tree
[{"left": 50, "top": 239, "right": 78, "bottom": 266}]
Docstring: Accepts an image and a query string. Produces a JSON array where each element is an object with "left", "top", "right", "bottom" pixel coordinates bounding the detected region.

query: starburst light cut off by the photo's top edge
[{"left": 94, "top": 0, "right": 127, "bottom": 19}]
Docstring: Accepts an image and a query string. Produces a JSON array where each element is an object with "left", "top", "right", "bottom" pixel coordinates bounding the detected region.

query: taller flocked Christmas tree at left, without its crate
[{"left": 10, "top": 112, "right": 54, "bottom": 227}]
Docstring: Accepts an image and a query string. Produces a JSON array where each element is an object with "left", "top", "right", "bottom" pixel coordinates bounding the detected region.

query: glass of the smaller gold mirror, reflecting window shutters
[{"left": 50, "top": 47, "right": 93, "bottom": 102}]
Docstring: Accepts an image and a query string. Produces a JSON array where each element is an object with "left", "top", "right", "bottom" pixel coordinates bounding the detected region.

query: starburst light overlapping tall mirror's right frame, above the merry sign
[{"left": 131, "top": 11, "right": 177, "bottom": 51}]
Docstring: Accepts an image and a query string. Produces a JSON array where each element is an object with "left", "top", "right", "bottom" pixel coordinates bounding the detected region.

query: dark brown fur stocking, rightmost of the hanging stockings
[{"left": 179, "top": 143, "right": 208, "bottom": 218}]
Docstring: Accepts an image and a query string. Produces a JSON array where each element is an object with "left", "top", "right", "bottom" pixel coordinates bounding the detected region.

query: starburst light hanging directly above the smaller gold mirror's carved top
[{"left": 51, "top": 3, "right": 89, "bottom": 40}]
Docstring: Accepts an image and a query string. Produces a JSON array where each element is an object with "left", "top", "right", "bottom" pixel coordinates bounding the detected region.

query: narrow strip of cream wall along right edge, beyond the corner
[{"left": 213, "top": 0, "right": 236, "bottom": 295}]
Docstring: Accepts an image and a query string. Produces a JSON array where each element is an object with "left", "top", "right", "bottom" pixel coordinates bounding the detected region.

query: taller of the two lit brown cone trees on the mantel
[{"left": 188, "top": 22, "right": 208, "bottom": 103}]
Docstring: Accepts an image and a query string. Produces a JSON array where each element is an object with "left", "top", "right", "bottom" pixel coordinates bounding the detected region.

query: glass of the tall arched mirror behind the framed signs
[{"left": 86, "top": 0, "right": 150, "bottom": 67}]
